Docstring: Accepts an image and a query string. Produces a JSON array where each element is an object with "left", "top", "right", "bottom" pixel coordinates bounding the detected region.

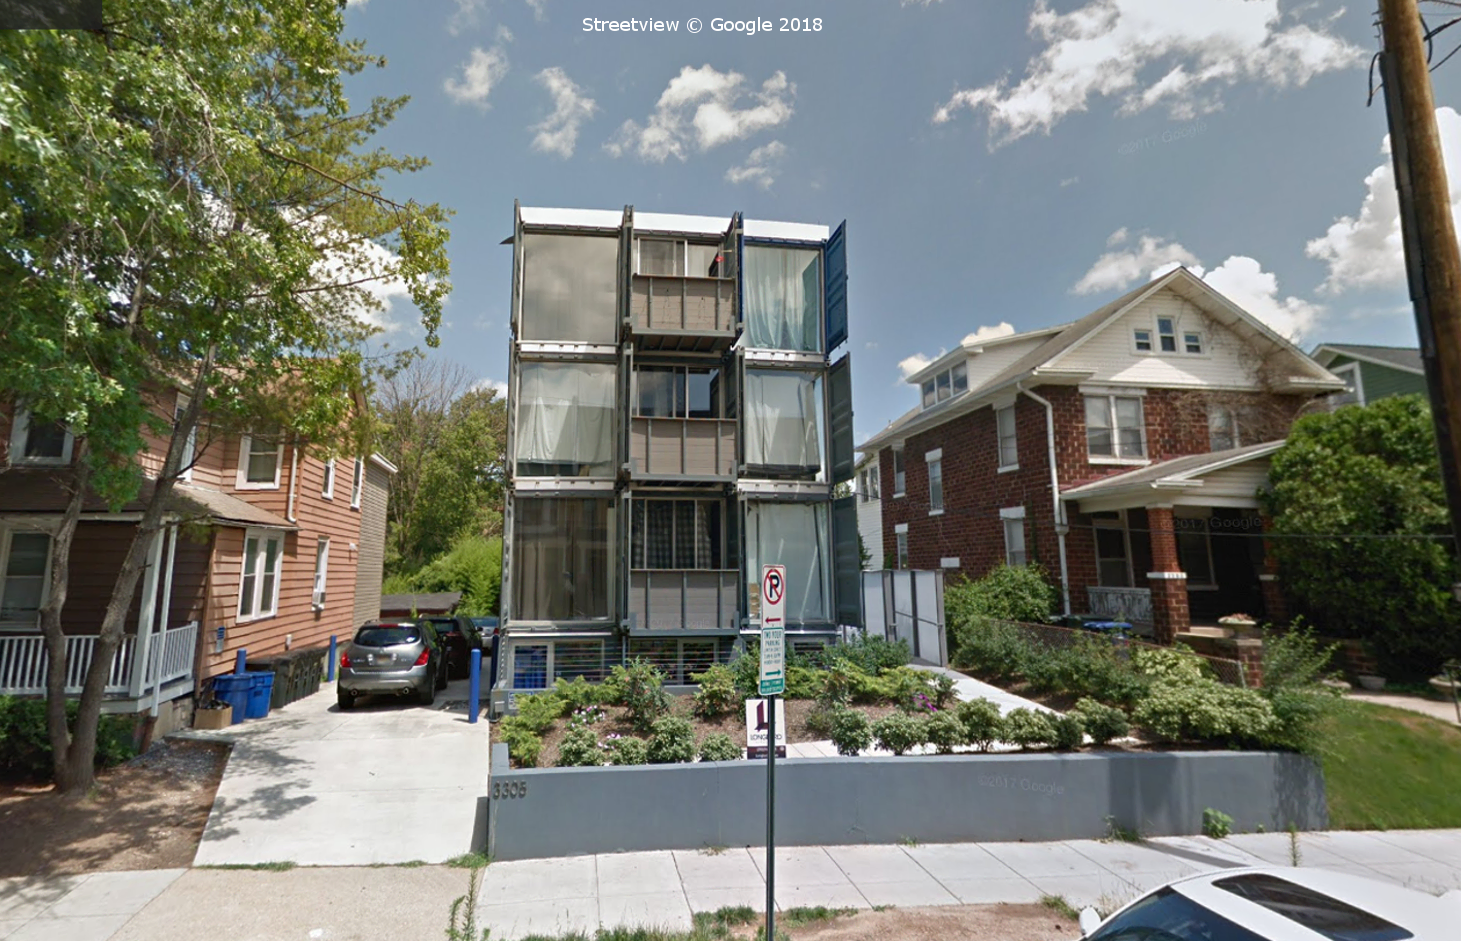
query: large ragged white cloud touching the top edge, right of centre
[{"left": 934, "top": 0, "right": 1367, "bottom": 146}]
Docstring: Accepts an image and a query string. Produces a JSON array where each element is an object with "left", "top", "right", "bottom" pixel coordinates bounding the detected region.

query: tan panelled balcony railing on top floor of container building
[{"left": 628, "top": 275, "right": 738, "bottom": 351}]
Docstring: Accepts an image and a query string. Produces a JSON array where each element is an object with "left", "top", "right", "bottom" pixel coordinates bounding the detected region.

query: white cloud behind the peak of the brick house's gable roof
[{"left": 1071, "top": 228, "right": 1324, "bottom": 340}]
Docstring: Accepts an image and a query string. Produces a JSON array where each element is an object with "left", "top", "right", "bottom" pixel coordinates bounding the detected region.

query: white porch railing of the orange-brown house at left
[{"left": 0, "top": 621, "right": 197, "bottom": 696}]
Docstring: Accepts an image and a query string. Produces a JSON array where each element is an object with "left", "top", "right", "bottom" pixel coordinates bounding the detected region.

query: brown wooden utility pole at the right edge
[{"left": 1379, "top": 0, "right": 1461, "bottom": 601}]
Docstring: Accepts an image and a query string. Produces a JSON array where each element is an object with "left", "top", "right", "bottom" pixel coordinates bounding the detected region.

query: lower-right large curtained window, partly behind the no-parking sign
[{"left": 745, "top": 501, "right": 831, "bottom": 624}]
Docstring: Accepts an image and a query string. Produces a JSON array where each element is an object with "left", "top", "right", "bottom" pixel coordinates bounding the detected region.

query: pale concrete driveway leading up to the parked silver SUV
[{"left": 193, "top": 679, "right": 489, "bottom": 866}]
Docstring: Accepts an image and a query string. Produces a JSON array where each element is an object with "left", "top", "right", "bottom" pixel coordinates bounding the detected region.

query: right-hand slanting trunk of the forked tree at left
[{"left": 57, "top": 348, "right": 215, "bottom": 793}]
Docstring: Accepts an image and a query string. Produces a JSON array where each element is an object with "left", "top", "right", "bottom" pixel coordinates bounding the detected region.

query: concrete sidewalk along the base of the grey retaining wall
[{"left": 478, "top": 830, "right": 1461, "bottom": 940}]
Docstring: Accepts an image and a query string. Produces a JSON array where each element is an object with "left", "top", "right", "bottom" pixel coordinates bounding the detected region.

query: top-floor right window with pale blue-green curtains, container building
[{"left": 742, "top": 245, "right": 821, "bottom": 352}]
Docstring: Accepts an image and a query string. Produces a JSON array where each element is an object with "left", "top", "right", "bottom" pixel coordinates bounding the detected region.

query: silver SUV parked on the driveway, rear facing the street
[{"left": 336, "top": 621, "right": 447, "bottom": 709}]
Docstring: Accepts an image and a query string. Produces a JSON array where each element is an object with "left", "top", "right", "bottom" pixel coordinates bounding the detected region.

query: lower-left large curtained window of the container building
[{"left": 513, "top": 497, "right": 618, "bottom": 621}]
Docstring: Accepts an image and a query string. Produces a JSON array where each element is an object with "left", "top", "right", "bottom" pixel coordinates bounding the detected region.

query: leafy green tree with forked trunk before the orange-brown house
[{"left": 0, "top": 0, "right": 450, "bottom": 792}]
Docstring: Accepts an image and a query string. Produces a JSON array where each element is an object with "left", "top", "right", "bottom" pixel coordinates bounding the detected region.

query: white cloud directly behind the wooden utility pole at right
[{"left": 1305, "top": 108, "right": 1461, "bottom": 295}]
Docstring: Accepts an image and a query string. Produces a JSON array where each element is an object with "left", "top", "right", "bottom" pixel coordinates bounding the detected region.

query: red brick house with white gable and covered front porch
[{"left": 859, "top": 267, "right": 1344, "bottom": 641}]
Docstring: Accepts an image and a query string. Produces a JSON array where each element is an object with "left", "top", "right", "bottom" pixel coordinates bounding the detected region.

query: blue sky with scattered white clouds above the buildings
[{"left": 336, "top": 0, "right": 1461, "bottom": 441}]
